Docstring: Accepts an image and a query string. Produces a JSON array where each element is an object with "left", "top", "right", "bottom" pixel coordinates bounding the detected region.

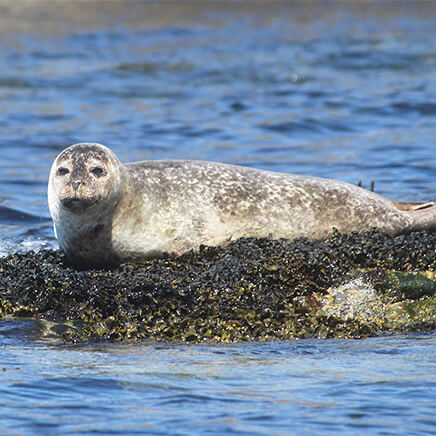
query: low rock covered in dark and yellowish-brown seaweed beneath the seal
[{"left": 0, "top": 232, "right": 436, "bottom": 342}]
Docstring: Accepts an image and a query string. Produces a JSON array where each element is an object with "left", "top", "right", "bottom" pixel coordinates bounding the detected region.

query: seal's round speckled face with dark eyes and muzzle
[{"left": 49, "top": 144, "right": 122, "bottom": 214}]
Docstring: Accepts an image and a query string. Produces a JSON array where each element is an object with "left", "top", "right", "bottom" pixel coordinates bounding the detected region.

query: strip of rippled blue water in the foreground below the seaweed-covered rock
[{"left": 0, "top": 328, "right": 436, "bottom": 435}]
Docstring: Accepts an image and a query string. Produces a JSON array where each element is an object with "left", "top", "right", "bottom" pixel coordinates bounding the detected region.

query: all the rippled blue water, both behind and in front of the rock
[{"left": 0, "top": 1, "right": 436, "bottom": 435}]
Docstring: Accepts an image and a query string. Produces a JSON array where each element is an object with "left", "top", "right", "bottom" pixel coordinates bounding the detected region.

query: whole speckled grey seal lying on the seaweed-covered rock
[{"left": 48, "top": 143, "right": 436, "bottom": 266}]
